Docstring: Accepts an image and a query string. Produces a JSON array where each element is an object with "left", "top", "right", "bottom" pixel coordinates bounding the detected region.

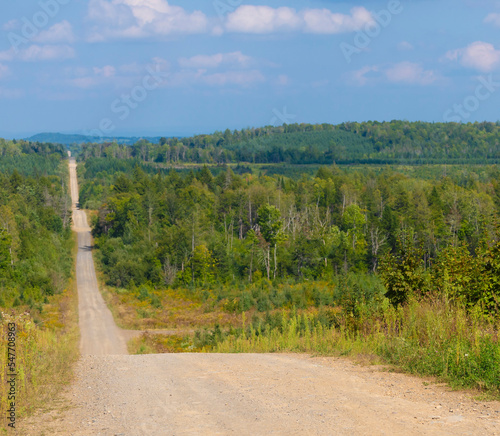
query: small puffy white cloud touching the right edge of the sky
[{"left": 445, "top": 41, "right": 500, "bottom": 72}]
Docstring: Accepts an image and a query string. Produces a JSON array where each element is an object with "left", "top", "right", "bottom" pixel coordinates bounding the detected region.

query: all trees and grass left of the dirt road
[{"left": 0, "top": 139, "right": 78, "bottom": 428}]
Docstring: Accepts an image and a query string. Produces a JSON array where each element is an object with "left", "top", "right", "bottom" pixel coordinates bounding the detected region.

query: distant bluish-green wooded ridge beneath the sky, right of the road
[{"left": 76, "top": 121, "right": 500, "bottom": 165}]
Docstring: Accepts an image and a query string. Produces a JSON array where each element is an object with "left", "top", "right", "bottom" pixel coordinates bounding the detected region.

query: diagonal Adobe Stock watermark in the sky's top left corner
[{"left": 7, "top": 0, "right": 71, "bottom": 53}]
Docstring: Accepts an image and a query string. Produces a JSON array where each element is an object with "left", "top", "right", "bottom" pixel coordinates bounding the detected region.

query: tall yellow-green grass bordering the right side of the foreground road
[{"left": 212, "top": 299, "right": 500, "bottom": 396}]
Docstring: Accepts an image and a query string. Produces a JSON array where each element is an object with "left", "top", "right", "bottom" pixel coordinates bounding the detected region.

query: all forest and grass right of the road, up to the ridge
[{"left": 75, "top": 121, "right": 500, "bottom": 395}]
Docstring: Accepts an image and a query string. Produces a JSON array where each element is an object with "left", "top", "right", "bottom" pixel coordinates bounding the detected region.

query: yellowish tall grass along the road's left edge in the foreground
[{"left": 0, "top": 287, "right": 79, "bottom": 431}]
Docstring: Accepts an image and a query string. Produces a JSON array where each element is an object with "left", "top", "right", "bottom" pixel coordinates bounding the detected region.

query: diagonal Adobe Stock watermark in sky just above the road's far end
[{"left": 83, "top": 64, "right": 169, "bottom": 140}]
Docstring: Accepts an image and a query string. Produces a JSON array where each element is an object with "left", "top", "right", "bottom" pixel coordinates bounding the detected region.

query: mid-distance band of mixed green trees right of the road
[{"left": 82, "top": 162, "right": 500, "bottom": 308}]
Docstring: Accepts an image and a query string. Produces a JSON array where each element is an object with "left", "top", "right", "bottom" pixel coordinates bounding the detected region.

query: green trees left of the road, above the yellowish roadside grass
[{"left": 0, "top": 164, "right": 73, "bottom": 311}]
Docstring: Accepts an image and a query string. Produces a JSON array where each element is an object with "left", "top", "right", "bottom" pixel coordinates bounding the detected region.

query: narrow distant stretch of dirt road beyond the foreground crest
[{"left": 69, "top": 158, "right": 127, "bottom": 355}]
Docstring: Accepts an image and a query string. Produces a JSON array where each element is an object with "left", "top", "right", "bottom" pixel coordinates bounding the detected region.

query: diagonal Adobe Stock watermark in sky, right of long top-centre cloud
[{"left": 340, "top": 0, "right": 404, "bottom": 64}]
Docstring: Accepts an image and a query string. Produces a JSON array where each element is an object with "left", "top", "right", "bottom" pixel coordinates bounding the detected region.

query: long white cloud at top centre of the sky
[{"left": 225, "top": 5, "right": 374, "bottom": 34}]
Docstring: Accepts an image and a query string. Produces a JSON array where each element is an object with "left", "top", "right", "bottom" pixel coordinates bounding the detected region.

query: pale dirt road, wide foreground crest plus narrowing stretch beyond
[{"left": 21, "top": 161, "right": 500, "bottom": 436}]
